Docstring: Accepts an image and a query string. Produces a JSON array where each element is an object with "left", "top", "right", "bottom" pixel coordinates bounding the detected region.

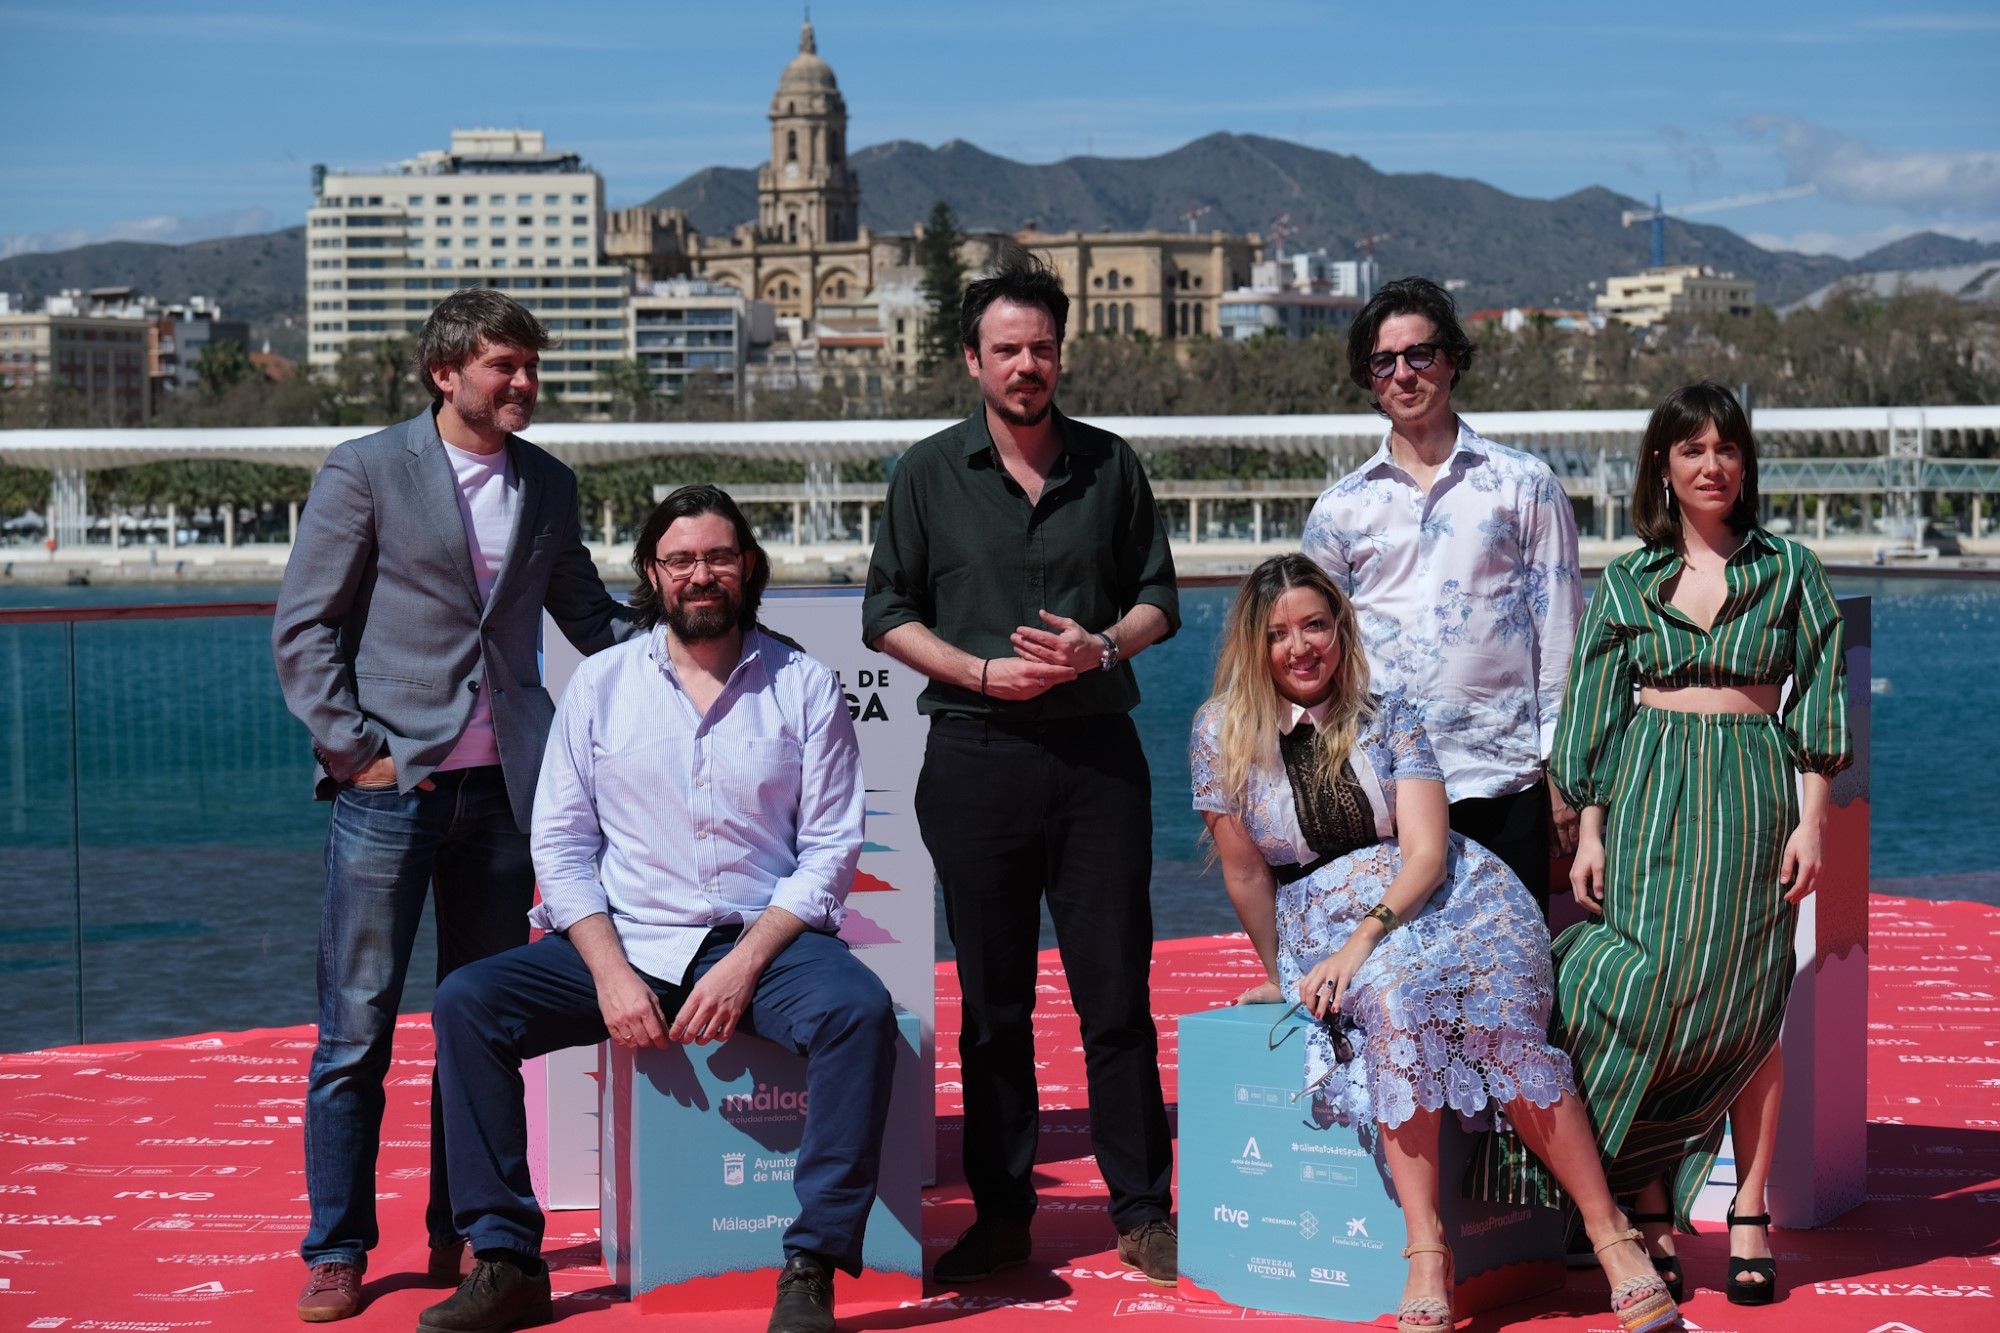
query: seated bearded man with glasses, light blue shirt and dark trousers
[{"left": 418, "top": 486, "right": 896, "bottom": 1333}]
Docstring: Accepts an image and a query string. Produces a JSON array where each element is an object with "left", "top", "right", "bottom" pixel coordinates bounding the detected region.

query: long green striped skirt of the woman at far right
[{"left": 1550, "top": 709, "right": 1798, "bottom": 1229}]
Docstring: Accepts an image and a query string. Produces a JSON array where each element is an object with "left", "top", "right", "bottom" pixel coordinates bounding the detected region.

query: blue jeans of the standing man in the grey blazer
[{"left": 298, "top": 767, "right": 534, "bottom": 1267}]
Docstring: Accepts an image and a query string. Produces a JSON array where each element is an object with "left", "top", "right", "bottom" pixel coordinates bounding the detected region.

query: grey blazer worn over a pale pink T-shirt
[{"left": 272, "top": 410, "right": 634, "bottom": 831}]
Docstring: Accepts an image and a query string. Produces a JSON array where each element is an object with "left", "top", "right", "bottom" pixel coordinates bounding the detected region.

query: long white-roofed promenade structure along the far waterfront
[{"left": 0, "top": 406, "right": 2000, "bottom": 582}]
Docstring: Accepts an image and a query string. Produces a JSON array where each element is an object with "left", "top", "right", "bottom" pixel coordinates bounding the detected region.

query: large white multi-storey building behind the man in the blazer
[{"left": 306, "top": 130, "right": 630, "bottom": 408}]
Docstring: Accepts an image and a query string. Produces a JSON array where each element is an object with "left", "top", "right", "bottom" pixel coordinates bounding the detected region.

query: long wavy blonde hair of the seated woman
[{"left": 1210, "top": 554, "right": 1374, "bottom": 803}]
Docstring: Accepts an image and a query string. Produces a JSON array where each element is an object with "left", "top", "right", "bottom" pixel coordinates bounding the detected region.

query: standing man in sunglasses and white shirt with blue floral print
[{"left": 1304, "top": 278, "right": 1582, "bottom": 913}]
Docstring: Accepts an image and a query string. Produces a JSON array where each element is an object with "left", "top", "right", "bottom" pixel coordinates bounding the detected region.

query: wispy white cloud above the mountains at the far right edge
[{"left": 1744, "top": 116, "right": 2000, "bottom": 216}]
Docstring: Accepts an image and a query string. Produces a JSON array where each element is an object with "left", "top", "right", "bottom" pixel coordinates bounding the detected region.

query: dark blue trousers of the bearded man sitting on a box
[{"left": 432, "top": 927, "right": 898, "bottom": 1273}]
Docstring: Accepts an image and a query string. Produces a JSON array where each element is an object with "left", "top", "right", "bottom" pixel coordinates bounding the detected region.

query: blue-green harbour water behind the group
[{"left": 0, "top": 578, "right": 2000, "bottom": 1051}]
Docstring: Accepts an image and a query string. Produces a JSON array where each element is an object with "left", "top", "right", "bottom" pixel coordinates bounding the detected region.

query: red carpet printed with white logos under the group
[{"left": 0, "top": 897, "right": 2000, "bottom": 1333}]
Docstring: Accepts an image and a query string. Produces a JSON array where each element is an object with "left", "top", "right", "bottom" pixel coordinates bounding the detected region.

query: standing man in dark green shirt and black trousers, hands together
[{"left": 862, "top": 252, "right": 1180, "bottom": 1285}]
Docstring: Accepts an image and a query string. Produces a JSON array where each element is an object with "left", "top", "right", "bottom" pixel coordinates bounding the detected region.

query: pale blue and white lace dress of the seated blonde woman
[{"left": 1190, "top": 695, "right": 1576, "bottom": 1129}]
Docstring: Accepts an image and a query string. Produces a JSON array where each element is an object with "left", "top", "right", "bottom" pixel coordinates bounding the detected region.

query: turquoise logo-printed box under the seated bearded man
[{"left": 600, "top": 1011, "right": 934, "bottom": 1309}]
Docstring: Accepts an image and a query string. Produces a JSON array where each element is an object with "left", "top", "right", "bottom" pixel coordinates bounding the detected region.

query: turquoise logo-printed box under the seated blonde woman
[{"left": 1180, "top": 1005, "right": 1564, "bottom": 1323}]
